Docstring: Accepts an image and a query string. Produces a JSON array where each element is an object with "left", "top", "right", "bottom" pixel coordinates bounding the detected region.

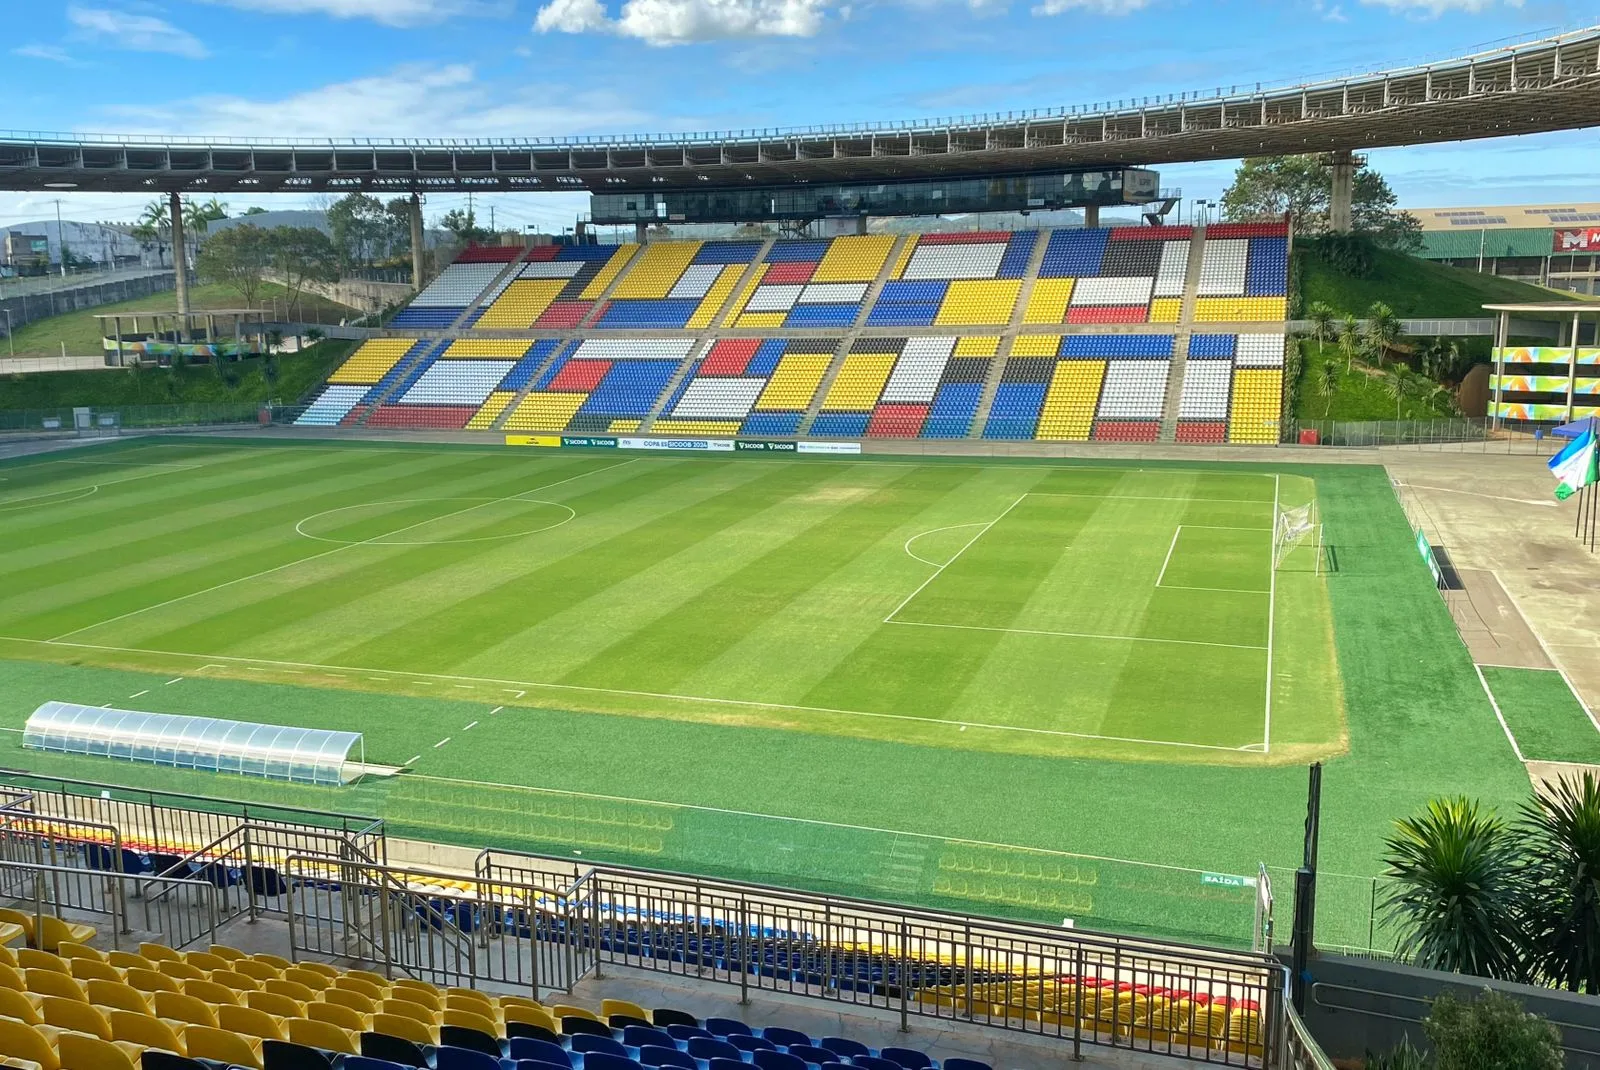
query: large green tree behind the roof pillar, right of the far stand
[{"left": 1222, "top": 155, "right": 1421, "bottom": 251}]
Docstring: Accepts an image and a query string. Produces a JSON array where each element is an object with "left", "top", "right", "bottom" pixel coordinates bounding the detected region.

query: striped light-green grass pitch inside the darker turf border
[{"left": 0, "top": 443, "right": 1342, "bottom": 764}]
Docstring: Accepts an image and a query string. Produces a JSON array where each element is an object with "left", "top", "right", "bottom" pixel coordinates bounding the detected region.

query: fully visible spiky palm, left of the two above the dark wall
[{"left": 1382, "top": 797, "right": 1522, "bottom": 979}]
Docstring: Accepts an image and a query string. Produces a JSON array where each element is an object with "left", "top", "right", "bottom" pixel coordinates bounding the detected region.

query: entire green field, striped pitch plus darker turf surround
[{"left": 0, "top": 438, "right": 1526, "bottom": 944}]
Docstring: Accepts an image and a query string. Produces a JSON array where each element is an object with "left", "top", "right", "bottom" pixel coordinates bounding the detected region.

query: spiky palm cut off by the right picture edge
[{"left": 1517, "top": 771, "right": 1600, "bottom": 995}]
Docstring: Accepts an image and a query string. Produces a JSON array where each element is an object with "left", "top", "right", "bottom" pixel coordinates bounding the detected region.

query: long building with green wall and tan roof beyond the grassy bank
[{"left": 1410, "top": 205, "right": 1600, "bottom": 294}]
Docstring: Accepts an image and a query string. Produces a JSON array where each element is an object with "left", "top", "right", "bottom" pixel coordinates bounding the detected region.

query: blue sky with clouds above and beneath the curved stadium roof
[{"left": 0, "top": 0, "right": 1600, "bottom": 235}]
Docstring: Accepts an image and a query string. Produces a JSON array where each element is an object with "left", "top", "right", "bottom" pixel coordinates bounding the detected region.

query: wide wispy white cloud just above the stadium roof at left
[{"left": 102, "top": 64, "right": 662, "bottom": 141}]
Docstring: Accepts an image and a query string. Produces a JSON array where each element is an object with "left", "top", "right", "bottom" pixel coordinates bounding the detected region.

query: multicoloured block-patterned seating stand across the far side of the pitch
[{"left": 296, "top": 224, "right": 1288, "bottom": 443}]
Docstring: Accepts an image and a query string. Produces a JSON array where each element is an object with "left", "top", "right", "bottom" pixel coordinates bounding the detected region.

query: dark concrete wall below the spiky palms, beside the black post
[{"left": 1306, "top": 955, "right": 1600, "bottom": 1070}]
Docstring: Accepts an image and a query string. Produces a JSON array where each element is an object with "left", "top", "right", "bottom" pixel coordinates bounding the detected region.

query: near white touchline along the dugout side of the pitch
[{"left": 9, "top": 633, "right": 1261, "bottom": 753}]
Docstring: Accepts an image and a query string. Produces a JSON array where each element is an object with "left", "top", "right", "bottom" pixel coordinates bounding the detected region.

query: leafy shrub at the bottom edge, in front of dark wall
[{"left": 1422, "top": 988, "right": 1566, "bottom": 1070}]
